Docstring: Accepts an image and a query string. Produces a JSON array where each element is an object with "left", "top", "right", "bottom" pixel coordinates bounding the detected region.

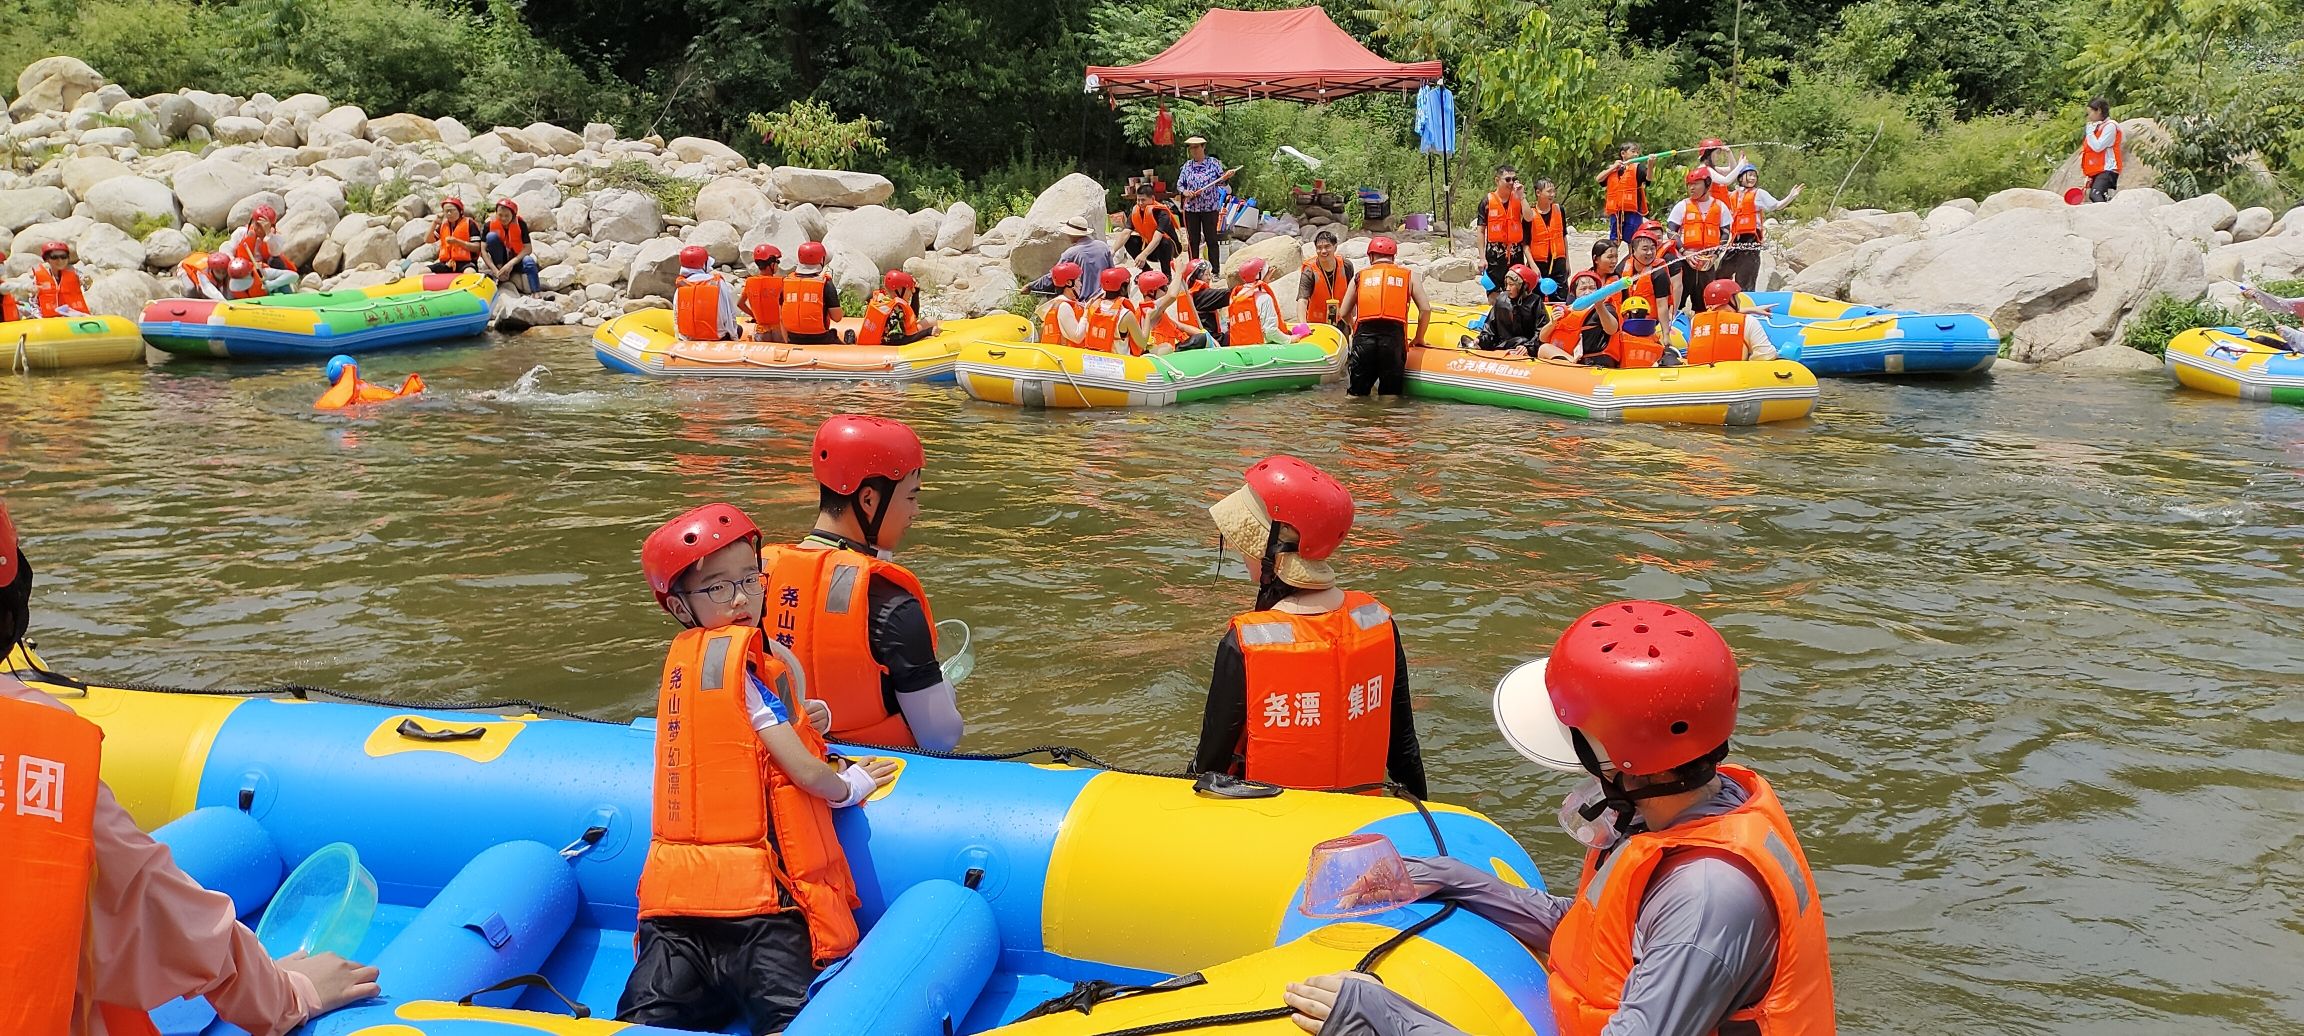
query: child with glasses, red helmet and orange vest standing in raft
[{"left": 615, "top": 504, "right": 896, "bottom": 1034}]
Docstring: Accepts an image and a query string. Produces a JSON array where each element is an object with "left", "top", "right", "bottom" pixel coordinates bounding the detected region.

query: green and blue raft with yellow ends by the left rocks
[{"left": 143, "top": 274, "right": 495, "bottom": 359}]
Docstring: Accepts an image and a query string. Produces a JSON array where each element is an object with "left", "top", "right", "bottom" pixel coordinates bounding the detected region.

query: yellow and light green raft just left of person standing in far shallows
[{"left": 958, "top": 325, "right": 1343, "bottom": 410}]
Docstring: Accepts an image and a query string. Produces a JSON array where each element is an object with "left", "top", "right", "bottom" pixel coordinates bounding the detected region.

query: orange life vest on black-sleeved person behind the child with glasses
[{"left": 763, "top": 546, "right": 935, "bottom": 748}]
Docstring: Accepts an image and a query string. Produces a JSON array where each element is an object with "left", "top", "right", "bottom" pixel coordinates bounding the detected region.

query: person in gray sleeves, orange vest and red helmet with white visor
[{"left": 1283, "top": 601, "right": 1834, "bottom": 1036}]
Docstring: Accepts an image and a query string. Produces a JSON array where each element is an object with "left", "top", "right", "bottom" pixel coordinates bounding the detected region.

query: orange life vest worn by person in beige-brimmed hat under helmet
[{"left": 1233, "top": 589, "right": 1401, "bottom": 792}]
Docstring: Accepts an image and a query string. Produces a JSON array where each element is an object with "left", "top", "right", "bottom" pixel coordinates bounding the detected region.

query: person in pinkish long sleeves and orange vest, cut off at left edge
[{"left": 0, "top": 504, "right": 376, "bottom": 1036}]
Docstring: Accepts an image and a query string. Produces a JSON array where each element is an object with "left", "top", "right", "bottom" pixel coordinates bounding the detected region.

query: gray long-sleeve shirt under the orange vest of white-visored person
[{"left": 1322, "top": 776, "right": 1776, "bottom": 1036}]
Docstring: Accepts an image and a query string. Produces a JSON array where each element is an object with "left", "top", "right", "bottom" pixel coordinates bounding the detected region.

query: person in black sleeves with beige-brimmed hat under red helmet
[{"left": 1191, "top": 456, "right": 1426, "bottom": 799}]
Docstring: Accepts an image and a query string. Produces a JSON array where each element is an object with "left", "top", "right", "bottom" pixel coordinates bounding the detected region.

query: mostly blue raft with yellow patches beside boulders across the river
[{"left": 1732, "top": 292, "right": 2000, "bottom": 378}]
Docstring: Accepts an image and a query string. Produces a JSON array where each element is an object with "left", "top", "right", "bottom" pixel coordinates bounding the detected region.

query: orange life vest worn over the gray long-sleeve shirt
[{"left": 1551, "top": 767, "right": 1836, "bottom": 1036}]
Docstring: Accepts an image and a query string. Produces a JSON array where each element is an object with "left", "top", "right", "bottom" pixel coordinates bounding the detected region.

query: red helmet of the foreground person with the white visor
[{"left": 1544, "top": 601, "right": 1740, "bottom": 776}]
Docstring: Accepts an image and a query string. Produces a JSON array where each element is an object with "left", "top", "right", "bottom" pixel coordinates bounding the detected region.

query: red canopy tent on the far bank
[{"left": 1087, "top": 7, "right": 1440, "bottom": 104}]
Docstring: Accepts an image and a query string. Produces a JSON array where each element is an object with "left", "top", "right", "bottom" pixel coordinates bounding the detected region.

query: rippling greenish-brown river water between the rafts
[{"left": 0, "top": 336, "right": 2304, "bottom": 1034}]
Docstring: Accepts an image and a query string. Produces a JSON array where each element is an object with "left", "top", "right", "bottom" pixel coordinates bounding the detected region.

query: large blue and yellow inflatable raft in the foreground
[{"left": 18, "top": 653, "right": 1555, "bottom": 1036}]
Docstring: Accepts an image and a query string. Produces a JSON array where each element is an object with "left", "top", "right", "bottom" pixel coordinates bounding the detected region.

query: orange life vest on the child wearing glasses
[{"left": 641, "top": 626, "right": 859, "bottom": 967}]
